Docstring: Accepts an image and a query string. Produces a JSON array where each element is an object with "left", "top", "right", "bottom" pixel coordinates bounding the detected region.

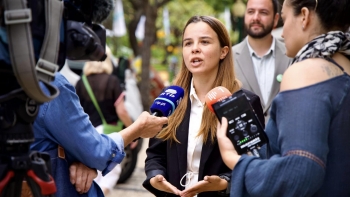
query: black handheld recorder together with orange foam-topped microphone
[{"left": 205, "top": 87, "right": 268, "bottom": 157}]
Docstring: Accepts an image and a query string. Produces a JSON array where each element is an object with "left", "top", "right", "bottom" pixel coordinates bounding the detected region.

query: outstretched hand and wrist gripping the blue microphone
[{"left": 119, "top": 111, "right": 168, "bottom": 147}]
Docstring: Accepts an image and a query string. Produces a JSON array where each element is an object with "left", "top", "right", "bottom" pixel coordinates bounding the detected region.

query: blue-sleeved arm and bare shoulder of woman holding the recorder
[{"left": 218, "top": 61, "right": 332, "bottom": 197}]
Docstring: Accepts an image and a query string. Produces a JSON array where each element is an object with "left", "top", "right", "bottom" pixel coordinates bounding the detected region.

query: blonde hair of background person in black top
[{"left": 83, "top": 46, "right": 113, "bottom": 76}]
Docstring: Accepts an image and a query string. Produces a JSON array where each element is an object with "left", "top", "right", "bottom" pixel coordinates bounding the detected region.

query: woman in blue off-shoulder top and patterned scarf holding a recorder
[{"left": 215, "top": 0, "right": 350, "bottom": 197}]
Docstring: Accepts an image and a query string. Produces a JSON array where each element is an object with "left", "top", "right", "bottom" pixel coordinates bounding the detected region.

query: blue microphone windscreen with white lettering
[{"left": 150, "top": 86, "right": 185, "bottom": 117}]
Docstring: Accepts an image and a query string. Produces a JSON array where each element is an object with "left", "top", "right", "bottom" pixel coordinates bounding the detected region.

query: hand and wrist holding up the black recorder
[{"left": 216, "top": 117, "right": 241, "bottom": 169}]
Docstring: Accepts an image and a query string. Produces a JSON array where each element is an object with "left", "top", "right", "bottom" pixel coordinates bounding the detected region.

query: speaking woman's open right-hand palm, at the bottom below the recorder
[{"left": 181, "top": 175, "right": 228, "bottom": 197}]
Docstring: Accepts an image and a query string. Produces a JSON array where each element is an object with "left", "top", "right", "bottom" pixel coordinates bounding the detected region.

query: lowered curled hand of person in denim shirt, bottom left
[{"left": 69, "top": 162, "right": 97, "bottom": 194}]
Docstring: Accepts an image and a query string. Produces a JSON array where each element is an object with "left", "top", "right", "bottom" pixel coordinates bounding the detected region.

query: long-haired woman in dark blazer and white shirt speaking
[{"left": 143, "top": 16, "right": 264, "bottom": 197}]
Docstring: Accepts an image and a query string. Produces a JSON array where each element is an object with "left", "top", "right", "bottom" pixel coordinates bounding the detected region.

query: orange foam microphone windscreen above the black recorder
[{"left": 205, "top": 86, "right": 231, "bottom": 112}]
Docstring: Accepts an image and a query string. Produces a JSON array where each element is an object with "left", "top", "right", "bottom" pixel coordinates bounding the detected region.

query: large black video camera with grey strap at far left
[{"left": 0, "top": 0, "right": 114, "bottom": 196}]
